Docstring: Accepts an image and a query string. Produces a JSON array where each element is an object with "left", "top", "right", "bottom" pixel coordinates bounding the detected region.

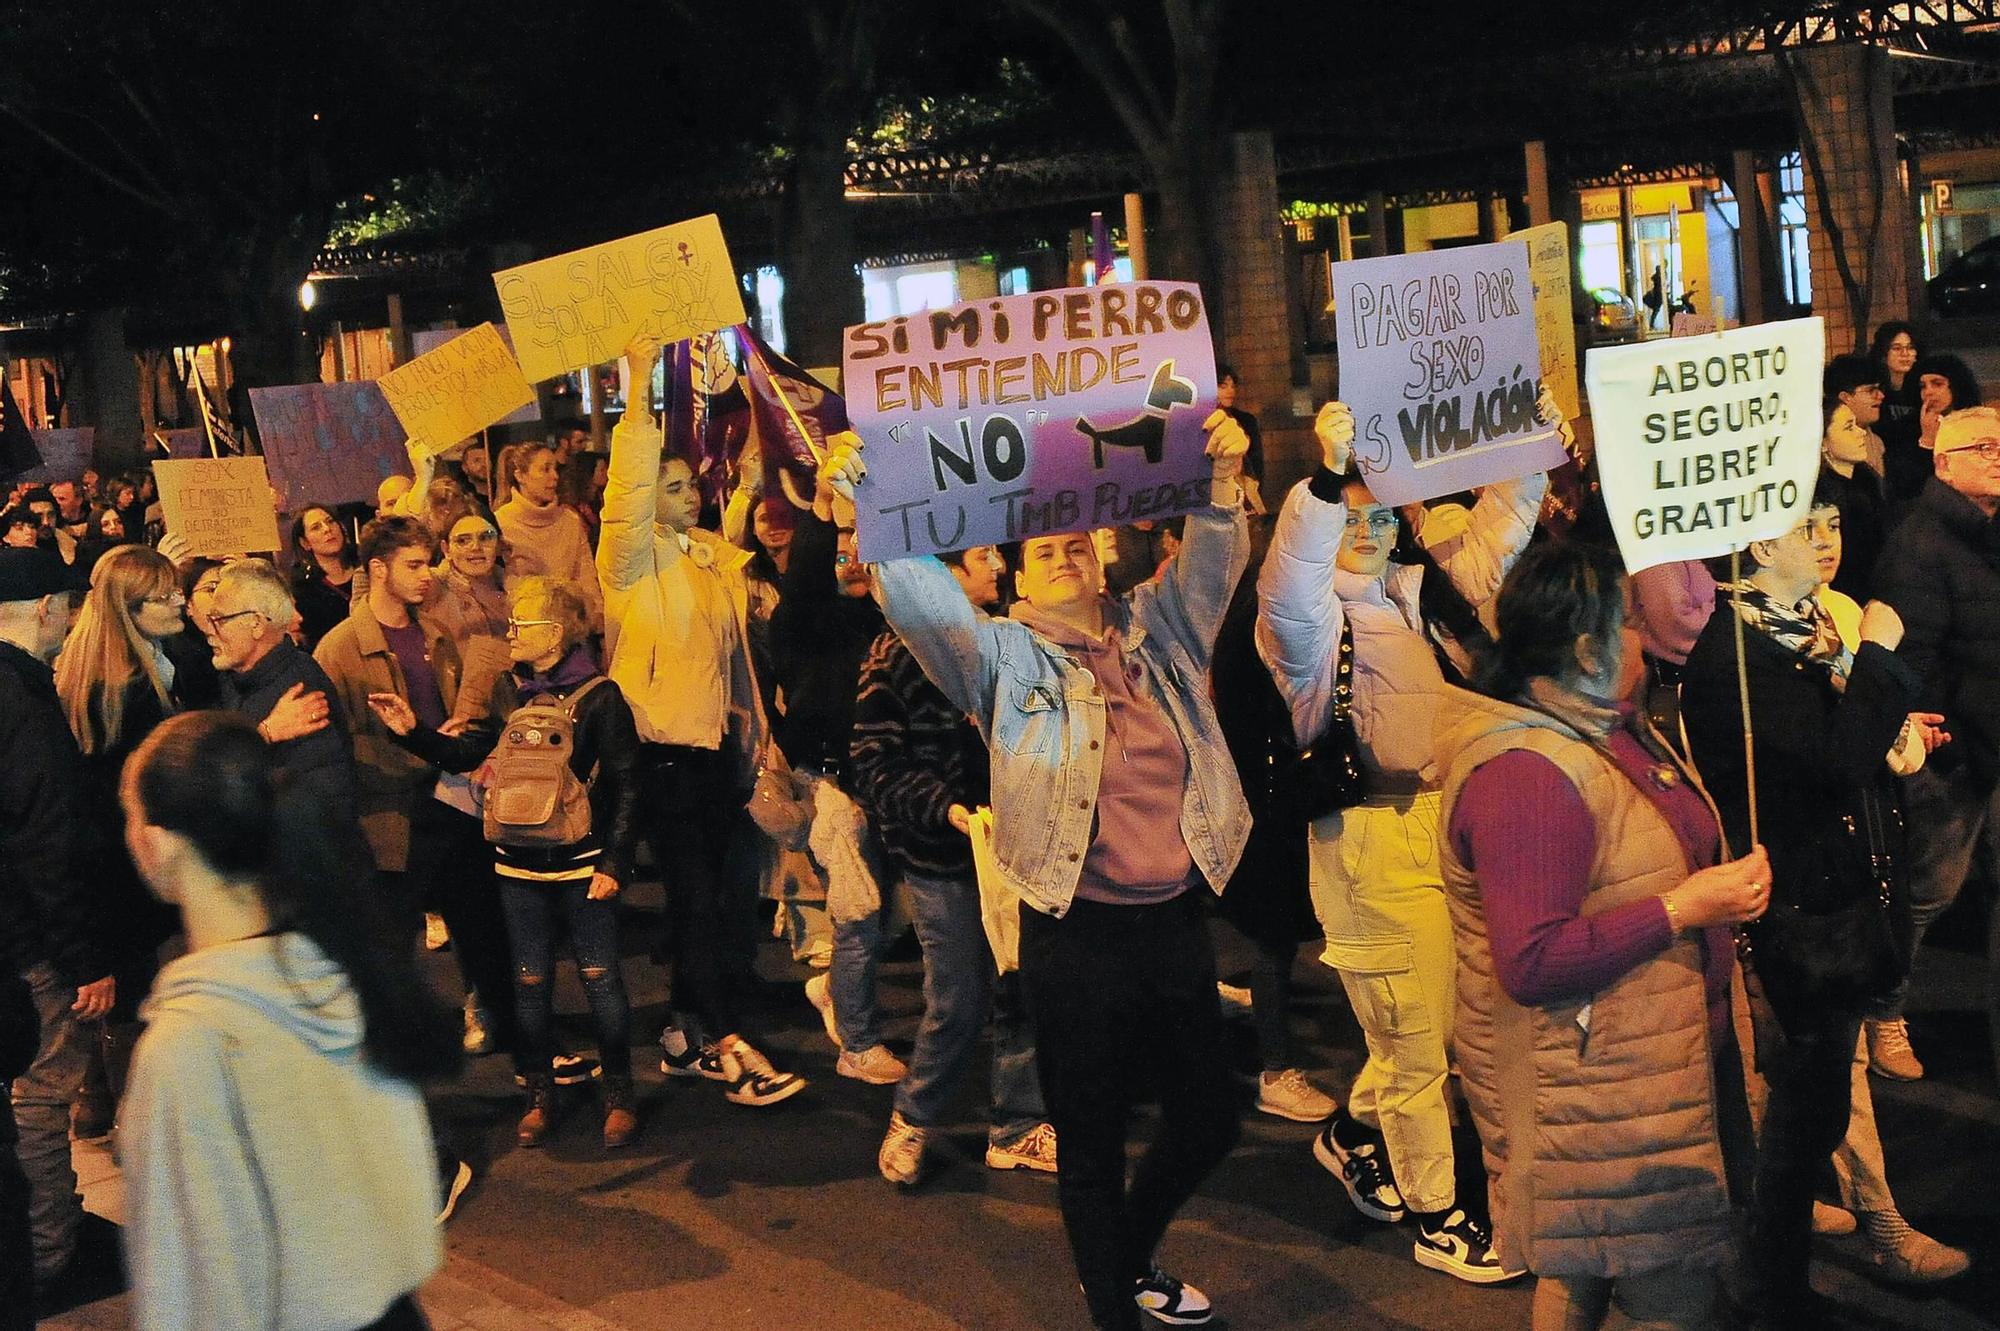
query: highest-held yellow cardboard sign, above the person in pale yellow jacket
[{"left": 494, "top": 214, "right": 744, "bottom": 384}]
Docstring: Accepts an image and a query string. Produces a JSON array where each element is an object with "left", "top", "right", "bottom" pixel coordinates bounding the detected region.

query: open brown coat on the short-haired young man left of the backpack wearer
[{"left": 312, "top": 602, "right": 506, "bottom": 873}]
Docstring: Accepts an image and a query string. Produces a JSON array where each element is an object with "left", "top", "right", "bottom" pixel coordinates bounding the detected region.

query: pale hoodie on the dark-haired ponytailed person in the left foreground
[{"left": 120, "top": 933, "right": 444, "bottom": 1331}]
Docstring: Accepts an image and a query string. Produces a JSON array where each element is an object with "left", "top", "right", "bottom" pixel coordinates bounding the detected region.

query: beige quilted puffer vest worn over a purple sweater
[{"left": 1438, "top": 689, "right": 1730, "bottom": 1277}]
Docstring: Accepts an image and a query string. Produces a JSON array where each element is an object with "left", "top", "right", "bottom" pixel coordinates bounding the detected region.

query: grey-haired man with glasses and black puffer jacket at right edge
[{"left": 1868, "top": 406, "right": 2000, "bottom": 1081}]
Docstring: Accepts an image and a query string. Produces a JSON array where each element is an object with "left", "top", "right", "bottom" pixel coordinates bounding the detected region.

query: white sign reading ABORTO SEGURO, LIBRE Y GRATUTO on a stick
[{"left": 1584, "top": 318, "right": 1826, "bottom": 574}]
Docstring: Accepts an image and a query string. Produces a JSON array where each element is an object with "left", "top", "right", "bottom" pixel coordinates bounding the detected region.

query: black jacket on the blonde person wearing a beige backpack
[{"left": 394, "top": 673, "right": 640, "bottom": 883}]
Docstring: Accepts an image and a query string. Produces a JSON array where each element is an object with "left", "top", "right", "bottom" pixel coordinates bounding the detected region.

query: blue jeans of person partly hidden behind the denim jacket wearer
[{"left": 892, "top": 873, "right": 1046, "bottom": 1143}]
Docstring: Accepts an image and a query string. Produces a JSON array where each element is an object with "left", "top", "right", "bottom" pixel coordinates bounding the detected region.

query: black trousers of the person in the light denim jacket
[{"left": 1020, "top": 891, "right": 1240, "bottom": 1331}]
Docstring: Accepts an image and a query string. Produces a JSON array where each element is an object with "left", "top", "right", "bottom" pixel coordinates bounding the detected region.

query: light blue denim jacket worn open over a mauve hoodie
[{"left": 876, "top": 497, "right": 1250, "bottom": 917}]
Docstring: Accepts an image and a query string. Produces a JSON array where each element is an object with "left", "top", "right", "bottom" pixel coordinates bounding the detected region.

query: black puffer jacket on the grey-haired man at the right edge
[{"left": 1874, "top": 478, "right": 2000, "bottom": 781}]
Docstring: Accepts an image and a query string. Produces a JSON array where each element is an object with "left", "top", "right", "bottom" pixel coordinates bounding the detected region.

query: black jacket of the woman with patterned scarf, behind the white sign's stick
[{"left": 1680, "top": 615, "right": 1916, "bottom": 1025}]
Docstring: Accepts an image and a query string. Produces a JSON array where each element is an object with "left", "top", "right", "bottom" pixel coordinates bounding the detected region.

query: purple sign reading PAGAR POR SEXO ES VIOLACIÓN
[{"left": 1334, "top": 240, "right": 1566, "bottom": 504}]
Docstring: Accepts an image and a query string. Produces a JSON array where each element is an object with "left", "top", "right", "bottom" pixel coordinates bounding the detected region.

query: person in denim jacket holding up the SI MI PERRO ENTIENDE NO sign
[{"left": 822, "top": 412, "right": 1250, "bottom": 1331}]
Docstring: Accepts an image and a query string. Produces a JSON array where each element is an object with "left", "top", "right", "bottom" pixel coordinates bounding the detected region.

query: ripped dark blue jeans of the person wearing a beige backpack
[{"left": 498, "top": 877, "right": 632, "bottom": 1077}]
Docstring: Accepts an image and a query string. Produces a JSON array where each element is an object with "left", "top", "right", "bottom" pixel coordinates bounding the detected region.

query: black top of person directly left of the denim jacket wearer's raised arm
[{"left": 770, "top": 514, "right": 888, "bottom": 771}]
